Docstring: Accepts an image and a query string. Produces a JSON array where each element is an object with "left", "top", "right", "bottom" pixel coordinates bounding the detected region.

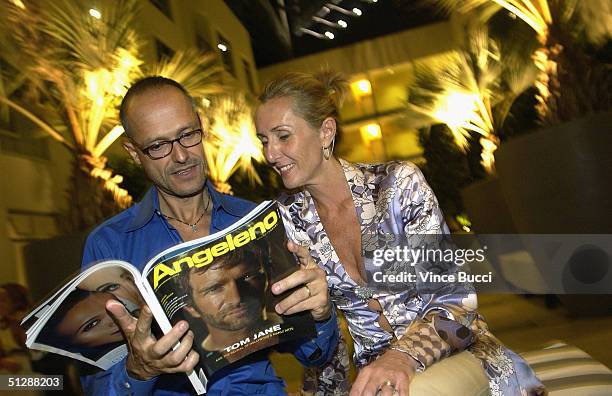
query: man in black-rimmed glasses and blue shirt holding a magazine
[{"left": 82, "top": 77, "right": 338, "bottom": 395}]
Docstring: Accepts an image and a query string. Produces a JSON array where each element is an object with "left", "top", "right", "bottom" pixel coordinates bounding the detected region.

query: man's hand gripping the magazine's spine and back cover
[{"left": 106, "top": 300, "right": 199, "bottom": 380}]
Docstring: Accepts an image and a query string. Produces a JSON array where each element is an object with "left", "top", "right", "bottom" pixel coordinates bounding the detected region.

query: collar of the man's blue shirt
[{"left": 126, "top": 179, "right": 244, "bottom": 232}]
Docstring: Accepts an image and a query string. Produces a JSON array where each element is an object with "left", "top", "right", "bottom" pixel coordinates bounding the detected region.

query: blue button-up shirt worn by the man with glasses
[{"left": 81, "top": 182, "right": 338, "bottom": 396}]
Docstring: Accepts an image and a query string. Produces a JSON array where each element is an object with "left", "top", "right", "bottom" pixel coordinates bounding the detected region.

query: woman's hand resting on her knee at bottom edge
[{"left": 350, "top": 349, "right": 418, "bottom": 396}]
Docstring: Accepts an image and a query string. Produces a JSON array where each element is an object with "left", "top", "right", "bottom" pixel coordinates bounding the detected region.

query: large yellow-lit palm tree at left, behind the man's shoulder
[{"left": 0, "top": 0, "right": 141, "bottom": 230}]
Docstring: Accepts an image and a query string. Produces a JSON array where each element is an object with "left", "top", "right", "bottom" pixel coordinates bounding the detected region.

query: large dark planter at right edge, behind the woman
[{"left": 496, "top": 112, "right": 612, "bottom": 315}]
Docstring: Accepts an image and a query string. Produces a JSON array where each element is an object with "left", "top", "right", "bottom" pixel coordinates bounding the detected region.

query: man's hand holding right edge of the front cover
[{"left": 272, "top": 241, "right": 331, "bottom": 321}]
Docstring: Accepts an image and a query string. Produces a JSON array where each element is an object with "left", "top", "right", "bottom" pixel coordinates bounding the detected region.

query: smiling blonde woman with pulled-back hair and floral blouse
[{"left": 256, "top": 73, "right": 544, "bottom": 395}]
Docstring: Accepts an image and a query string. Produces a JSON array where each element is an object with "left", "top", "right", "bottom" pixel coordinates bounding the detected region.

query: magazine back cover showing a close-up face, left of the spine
[{"left": 26, "top": 260, "right": 144, "bottom": 369}]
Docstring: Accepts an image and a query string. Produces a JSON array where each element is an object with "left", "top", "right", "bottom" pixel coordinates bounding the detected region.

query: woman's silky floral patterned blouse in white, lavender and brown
[{"left": 278, "top": 159, "right": 544, "bottom": 395}]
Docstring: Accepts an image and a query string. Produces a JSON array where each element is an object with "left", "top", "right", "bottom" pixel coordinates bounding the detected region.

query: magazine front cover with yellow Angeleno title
[{"left": 143, "top": 203, "right": 315, "bottom": 376}]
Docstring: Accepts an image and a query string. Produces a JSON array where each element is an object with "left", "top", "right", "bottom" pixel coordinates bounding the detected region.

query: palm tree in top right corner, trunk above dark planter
[{"left": 425, "top": 0, "right": 612, "bottom": 125}]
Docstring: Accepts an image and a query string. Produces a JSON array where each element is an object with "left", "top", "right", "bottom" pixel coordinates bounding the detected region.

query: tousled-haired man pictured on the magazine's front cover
[{"left": 179, "top": 241, "right": 283, "bottom": 369}]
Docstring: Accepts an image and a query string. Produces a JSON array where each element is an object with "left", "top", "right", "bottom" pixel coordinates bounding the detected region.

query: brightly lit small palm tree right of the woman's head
[{"left": 407, "top": 27, "right": 534, "bottom": 174}]
